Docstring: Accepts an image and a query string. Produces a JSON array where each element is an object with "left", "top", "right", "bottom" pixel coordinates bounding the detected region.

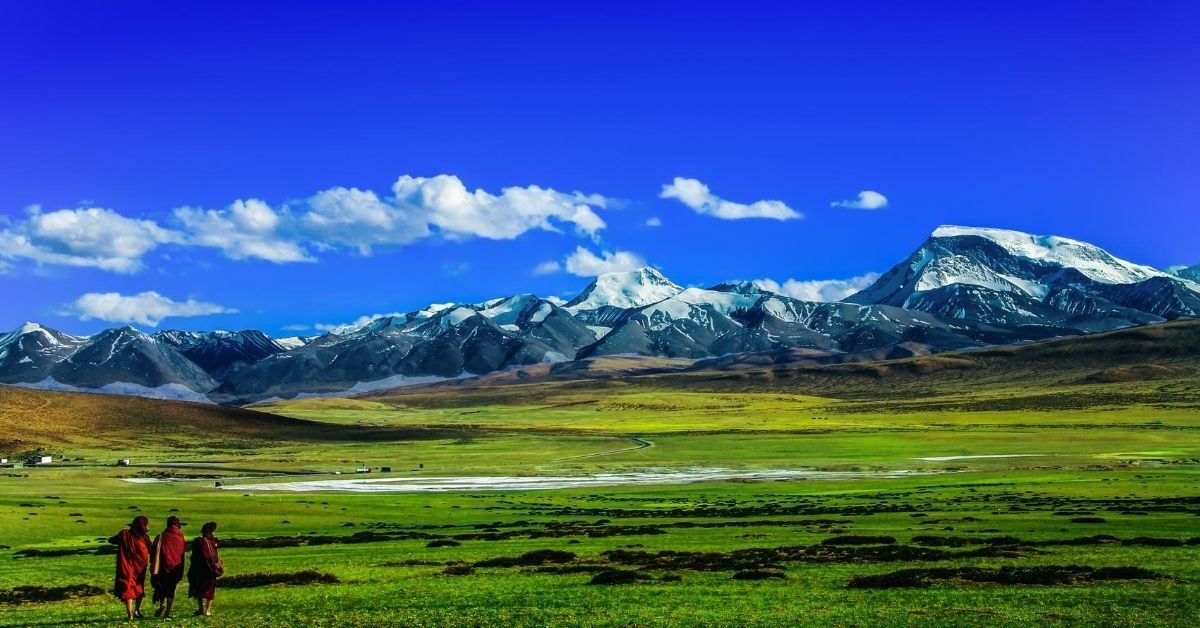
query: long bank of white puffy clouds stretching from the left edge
[{"left": 0, "top": 174, "right": 608, "bottom": 273}]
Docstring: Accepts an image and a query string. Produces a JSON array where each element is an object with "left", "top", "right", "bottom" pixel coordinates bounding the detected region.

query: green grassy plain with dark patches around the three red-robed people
[{"left": 0, "top": 321, "right": 1200, "bottom": 626}]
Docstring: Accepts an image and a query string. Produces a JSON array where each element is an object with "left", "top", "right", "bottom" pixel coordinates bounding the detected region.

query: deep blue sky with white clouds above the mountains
[{"left": 0, "top": 0, "right": 1200, "bottom": 334}]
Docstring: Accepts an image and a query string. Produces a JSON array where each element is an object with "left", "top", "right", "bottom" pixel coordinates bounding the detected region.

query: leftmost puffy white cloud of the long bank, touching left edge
[{"left": 0, "top": 207, "right": 182, "bottom": 273}]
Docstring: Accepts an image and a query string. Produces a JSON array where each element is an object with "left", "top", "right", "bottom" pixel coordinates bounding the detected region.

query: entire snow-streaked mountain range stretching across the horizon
[{"left": 0, "top": 227, "right": 1200, "bottom": 403}]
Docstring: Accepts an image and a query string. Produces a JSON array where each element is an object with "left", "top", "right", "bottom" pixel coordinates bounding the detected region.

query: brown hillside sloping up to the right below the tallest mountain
[{"left": 371, "top": 319, "right": 1200, "bottom": 406}]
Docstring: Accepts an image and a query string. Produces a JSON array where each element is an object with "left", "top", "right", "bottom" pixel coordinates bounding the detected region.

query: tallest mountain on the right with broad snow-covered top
[{"left": 847, "top": 227, "right": 1200, "bottom": 331}]
